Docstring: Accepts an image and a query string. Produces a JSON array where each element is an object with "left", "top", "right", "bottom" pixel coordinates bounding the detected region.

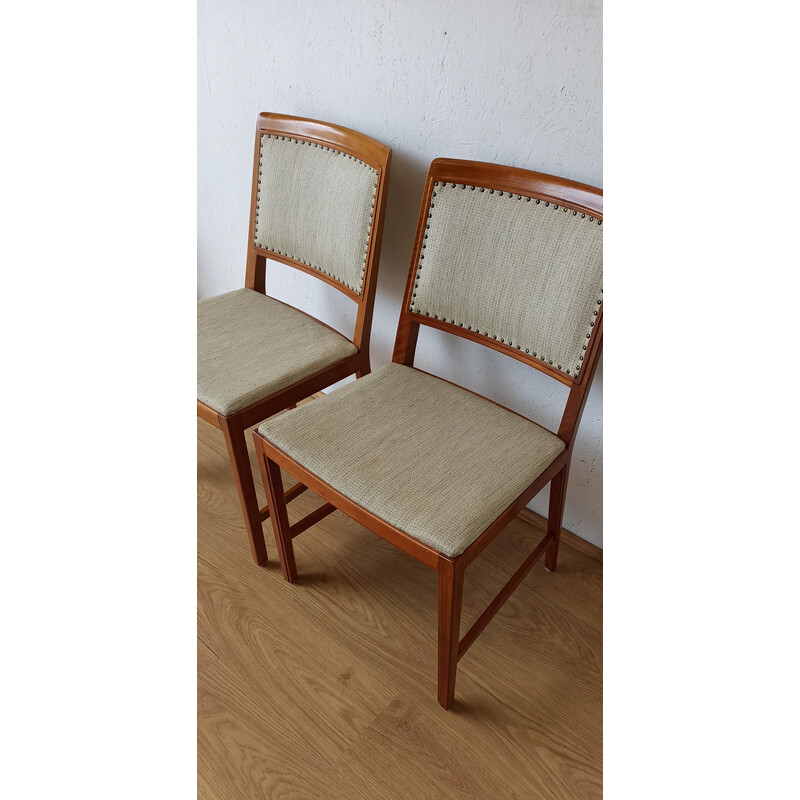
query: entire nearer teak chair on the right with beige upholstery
[{"left": 254, "top": 159, "right": 603, "bottom": 709}]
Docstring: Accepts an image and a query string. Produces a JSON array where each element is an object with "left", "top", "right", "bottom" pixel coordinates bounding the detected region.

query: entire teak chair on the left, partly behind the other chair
[{"left": 197, "top": 114, "right": 391, "bottom": 564}]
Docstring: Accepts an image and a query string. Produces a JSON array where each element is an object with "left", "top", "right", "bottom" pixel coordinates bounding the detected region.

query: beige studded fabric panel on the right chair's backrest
[{"left": 410, "top": 183, "right": 603, "bottom": 376}]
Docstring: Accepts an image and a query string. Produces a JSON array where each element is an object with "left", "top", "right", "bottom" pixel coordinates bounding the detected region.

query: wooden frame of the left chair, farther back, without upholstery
[{"left": 197, "top": 113, "right": 392, "bottom": 565}]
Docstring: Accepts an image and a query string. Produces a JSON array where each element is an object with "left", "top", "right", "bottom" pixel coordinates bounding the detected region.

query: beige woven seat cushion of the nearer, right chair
[{"left": 258, "top": 364, "right": 565, "bottom": 556}]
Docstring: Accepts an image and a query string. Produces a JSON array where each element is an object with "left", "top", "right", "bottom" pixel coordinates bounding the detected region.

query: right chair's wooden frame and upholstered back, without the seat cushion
[{"left": 254, "top": 159, "right": 603, "bottom": 709}]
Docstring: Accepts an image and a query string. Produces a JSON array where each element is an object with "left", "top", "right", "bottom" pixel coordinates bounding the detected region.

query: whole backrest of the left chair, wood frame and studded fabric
[{"left": 245, "top": 113, "right": 391, "bottom": 354}]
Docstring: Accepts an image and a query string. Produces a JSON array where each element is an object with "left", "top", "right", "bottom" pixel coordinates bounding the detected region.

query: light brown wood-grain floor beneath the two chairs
[{"left": 197, "top": 420, "right": 602, "bottom": 800}]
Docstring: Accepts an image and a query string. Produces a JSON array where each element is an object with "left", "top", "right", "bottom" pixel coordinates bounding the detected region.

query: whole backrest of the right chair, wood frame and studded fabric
[{"left": 394, "top": 159, "right": 603, "bottom": 440}]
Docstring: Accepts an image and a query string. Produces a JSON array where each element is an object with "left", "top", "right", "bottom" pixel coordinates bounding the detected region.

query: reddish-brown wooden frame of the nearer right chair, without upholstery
[{"left": 254, "top": 159, "right": 603, "bottom": 709}]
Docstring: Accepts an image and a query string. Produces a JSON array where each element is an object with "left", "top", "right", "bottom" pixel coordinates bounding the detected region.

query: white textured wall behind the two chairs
[{"left": 198, "top": 0, "right": 603, "bottom": 546}]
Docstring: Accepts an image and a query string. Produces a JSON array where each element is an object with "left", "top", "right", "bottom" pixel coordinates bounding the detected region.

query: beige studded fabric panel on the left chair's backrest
[{"left": 254, "top": 134, "right": 378, "bottom": 294}]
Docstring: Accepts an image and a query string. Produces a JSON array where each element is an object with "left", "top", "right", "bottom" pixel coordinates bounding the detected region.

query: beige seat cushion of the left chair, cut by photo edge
[{"left": 197, "top": 289, "right": 358, "bottom": 416}]
